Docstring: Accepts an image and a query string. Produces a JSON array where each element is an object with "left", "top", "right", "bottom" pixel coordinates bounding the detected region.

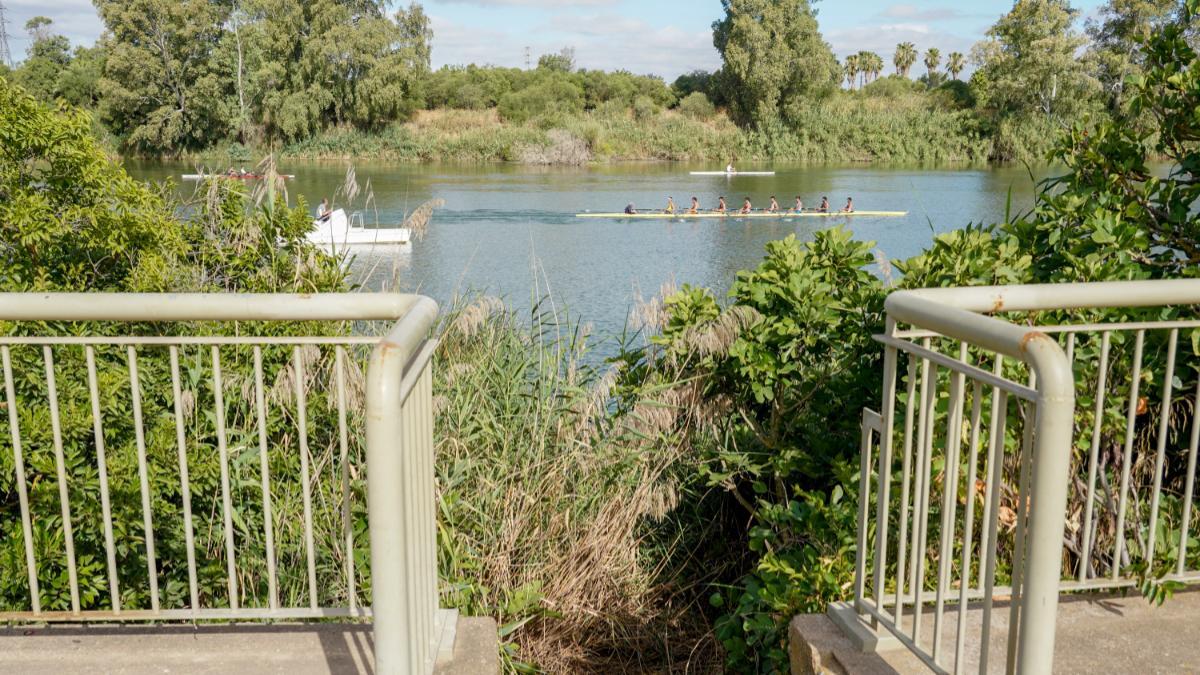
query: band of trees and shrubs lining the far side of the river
[{"left": 0, "top": 0, "right": 1180, "bottom": 163}]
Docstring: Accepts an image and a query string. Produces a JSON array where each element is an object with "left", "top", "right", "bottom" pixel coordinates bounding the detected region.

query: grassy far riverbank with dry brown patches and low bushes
[{"left": 171, "top": 94, "right": 1052, "bottom": 166}]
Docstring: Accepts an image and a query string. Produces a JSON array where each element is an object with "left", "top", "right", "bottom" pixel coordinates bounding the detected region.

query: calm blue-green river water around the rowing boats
[{"left": 126, "top": 162, "right": 1051, "bottom": 335}]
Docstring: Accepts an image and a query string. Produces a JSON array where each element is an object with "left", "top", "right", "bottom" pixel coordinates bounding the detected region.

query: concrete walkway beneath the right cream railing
[{"left": 788, "top": 590, "right": 1200, "bottom": 675}]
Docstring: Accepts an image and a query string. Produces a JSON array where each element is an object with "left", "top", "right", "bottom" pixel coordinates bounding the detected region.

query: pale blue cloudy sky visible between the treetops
[{"left": 0, "top": 0, "right": 1103, "bottom": 80}]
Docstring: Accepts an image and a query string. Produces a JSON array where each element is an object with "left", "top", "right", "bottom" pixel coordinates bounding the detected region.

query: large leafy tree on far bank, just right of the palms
[{"left": 971, "top": 0, "right": 1098, "bottom": 118}]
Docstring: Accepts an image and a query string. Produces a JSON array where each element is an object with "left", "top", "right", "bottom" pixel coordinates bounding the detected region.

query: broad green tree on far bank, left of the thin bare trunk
[{"left": 96, "top": 0, "right": 232, "bottom": 153}]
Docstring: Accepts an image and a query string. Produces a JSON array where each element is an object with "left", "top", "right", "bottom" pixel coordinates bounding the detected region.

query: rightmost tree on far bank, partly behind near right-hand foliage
[{"left": 1087, "top": 0, "right": 1178, "bottom": 108}]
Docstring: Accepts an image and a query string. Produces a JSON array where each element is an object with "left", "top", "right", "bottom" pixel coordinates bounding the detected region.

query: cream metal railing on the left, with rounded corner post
[{"left": 0, "top": 293, "right": 455, "bottom": 674}]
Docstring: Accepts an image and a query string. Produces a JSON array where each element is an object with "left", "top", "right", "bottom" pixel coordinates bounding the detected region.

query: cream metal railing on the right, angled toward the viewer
[{"left": 853, "top": 280, "right": 1200, "bottom": 673}]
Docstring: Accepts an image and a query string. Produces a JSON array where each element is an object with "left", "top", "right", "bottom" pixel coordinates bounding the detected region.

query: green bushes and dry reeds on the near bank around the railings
[{"left": 0, "top": 0, "right": 1200, "bottom": 673}]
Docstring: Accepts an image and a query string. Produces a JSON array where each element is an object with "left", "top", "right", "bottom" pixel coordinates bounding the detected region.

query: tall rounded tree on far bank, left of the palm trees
[{"left": 713, "top": 0, "right": 840, "bottom": 126}]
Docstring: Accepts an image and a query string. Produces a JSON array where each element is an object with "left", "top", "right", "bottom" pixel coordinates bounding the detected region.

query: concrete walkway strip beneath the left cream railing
[{"left": 0, "top": 619, "right": 498, "bottom": 675}]
